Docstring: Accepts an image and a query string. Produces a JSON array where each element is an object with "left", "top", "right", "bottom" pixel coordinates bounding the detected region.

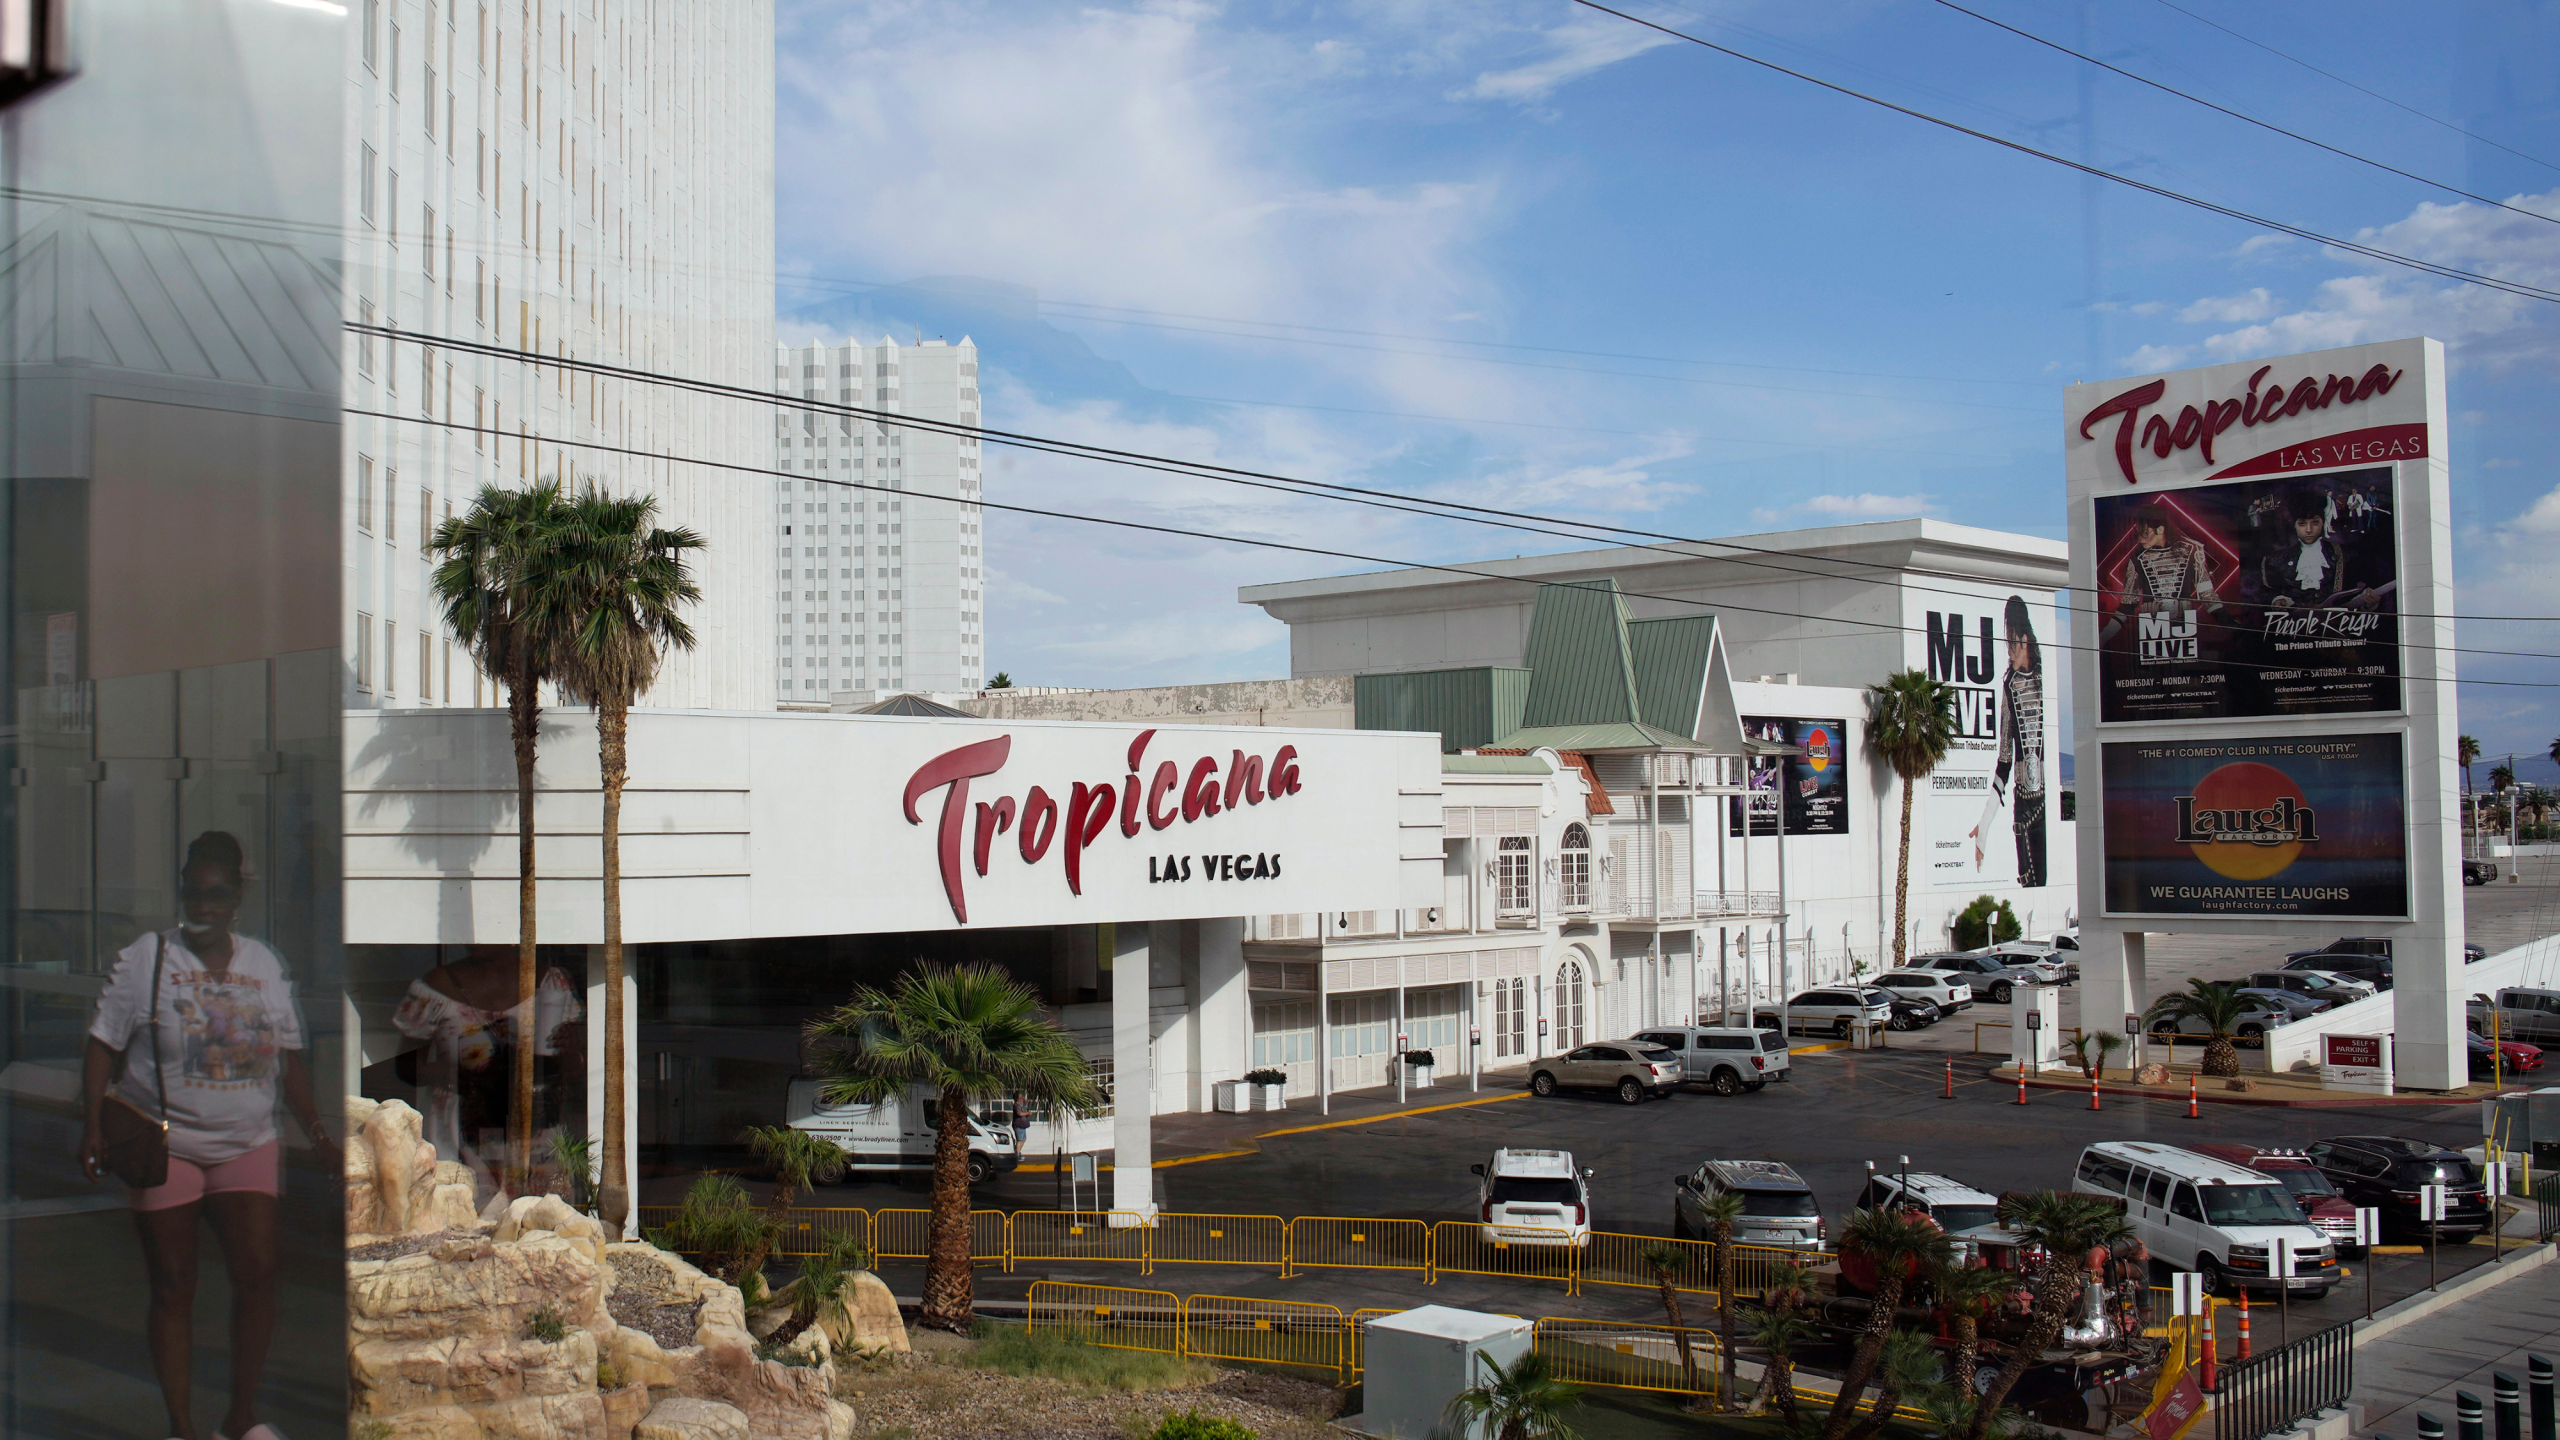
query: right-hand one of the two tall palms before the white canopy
[{"left": 535, "top": 482, "right": 704, "bottom": 1230}]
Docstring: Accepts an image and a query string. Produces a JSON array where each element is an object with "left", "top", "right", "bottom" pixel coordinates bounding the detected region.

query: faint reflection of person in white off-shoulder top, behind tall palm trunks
[{"left": 392, "top": 945, "right": 586, "bottom": 1189}]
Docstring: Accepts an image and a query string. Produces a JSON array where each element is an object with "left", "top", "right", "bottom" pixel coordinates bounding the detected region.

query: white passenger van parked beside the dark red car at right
[{"left": 2071, "top": 1140, "right": 2337, "bottom": 1299}]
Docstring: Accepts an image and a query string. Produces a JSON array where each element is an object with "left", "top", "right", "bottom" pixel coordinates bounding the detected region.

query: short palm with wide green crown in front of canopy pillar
[{"left": 809, "top": 963, "right": 1101, "bottom": 1335}]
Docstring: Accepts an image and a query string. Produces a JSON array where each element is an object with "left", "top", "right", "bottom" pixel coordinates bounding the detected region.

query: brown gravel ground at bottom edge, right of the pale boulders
[{"left": 837, "top": 1330, "right": 1341, "bottom": 1440}]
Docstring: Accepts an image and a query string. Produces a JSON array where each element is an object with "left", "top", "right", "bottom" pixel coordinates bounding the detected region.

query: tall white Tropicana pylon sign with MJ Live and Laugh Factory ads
[{"left": 2063, "top": 338, "right": 2468, "bottom": 1089}]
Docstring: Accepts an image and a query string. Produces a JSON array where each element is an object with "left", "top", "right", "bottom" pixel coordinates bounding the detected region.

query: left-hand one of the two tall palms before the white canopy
[{"left": 428, "top": 484, "right": 568, "bottom": 1191}]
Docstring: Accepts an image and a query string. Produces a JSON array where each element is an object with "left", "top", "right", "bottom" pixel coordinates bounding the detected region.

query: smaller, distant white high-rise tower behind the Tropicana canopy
[{"left": 773, "top": 336, "right": 986, "bottom": 705}]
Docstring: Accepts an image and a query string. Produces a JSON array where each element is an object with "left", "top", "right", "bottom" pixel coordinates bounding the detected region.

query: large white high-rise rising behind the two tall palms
[{"left": 343, "top": 0, "right": 773, "bottom": 710}]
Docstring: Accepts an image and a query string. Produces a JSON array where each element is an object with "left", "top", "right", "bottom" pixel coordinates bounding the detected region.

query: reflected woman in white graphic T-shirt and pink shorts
[{"left": 79, "top": 830, "right": 340, "bottom": 1440}]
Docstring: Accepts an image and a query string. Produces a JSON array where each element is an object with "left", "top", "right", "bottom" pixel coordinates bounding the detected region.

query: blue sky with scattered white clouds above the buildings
[{"left": 778, "top": 0, "right": 2560, "bottom": 779}]
